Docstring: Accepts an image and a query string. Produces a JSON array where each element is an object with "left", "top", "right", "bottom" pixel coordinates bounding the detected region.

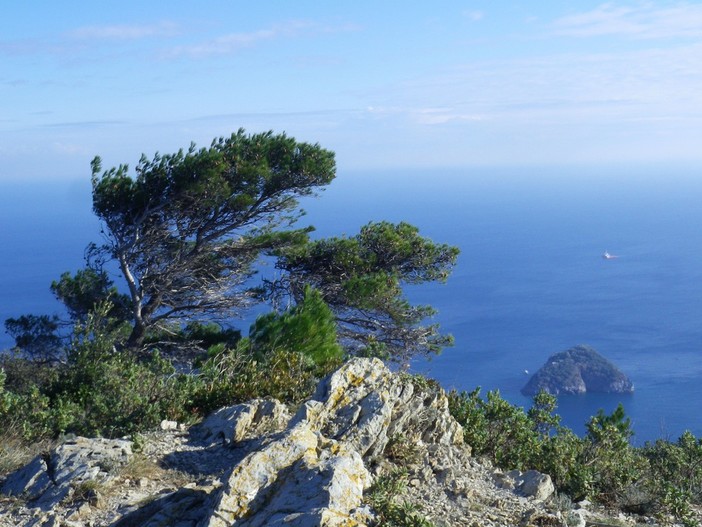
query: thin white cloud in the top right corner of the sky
[{"left": 554, "top": 3, "right": 702, "bottom": 39}]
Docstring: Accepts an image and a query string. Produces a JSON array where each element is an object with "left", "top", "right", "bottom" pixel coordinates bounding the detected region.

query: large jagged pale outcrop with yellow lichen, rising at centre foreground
[{"left": 201, "top": 359, "right": 463, "bottom": 527}]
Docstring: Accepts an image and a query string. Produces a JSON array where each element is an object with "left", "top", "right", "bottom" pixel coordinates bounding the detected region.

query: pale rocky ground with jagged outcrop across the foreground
[{"left": 0, "top": 359, "right": 660, "bottom": 527}]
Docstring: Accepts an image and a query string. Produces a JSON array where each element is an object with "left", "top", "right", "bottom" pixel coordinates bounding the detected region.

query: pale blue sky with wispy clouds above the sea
[{"left": 0, "top": 0, "right": 702, "bottom": 181}]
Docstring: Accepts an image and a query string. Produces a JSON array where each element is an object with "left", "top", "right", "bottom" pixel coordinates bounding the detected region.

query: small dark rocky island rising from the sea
[{"left": 522, "top": 345, "right": 634, "bottom": 395}]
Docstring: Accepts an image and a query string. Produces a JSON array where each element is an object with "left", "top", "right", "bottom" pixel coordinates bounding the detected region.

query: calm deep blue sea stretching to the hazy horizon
[{"left": 0, "top": 166, "right": 702, "bottom": 445}]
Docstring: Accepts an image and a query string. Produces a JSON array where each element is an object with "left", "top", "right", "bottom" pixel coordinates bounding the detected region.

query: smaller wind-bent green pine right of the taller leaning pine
[{"left": 267, "top": 222, "right": 459, "bottom": 360}]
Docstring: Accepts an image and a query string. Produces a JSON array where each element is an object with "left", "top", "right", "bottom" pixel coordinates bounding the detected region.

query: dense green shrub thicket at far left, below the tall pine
[{"left": 0, "top": 304, "right": 204, "bottom": 441}]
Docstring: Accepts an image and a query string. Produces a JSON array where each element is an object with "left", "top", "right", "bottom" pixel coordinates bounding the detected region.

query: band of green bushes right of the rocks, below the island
[{"left": 449, "top": 388, "right": 702, "bottom": 525}]
